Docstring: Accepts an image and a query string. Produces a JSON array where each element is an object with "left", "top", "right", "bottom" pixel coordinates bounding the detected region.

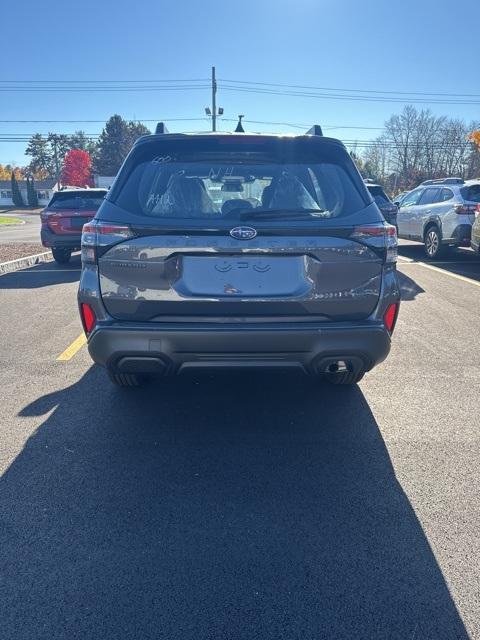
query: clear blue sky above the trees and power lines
[{"left": 0, "top": 0, "right": 480, "bottom": 164}]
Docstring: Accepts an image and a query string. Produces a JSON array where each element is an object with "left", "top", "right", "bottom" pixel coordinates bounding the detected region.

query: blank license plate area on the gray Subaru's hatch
[{"left": 175, "top": 256, "right": 311, "bottom": 298}]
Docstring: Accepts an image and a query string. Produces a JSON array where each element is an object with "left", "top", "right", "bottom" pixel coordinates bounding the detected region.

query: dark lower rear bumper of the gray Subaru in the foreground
[{"left": 88, "top": 322, "right": 391, "bottom": 375}]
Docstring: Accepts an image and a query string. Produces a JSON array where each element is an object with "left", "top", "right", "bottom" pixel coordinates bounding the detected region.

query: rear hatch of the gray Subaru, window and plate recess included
[{"left": 91, "top": 136, "right": 387, "bottom": 322}]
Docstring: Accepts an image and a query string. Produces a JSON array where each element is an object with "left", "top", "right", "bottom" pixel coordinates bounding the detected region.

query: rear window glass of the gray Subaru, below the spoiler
[{"left": 116, "top": 140, "right": 365, "bottom": 221}]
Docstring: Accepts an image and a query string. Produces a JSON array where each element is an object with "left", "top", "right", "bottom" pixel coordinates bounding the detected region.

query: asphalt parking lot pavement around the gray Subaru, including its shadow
[{"left": 0, "top": 243, "right": 480, "bottom": 640}]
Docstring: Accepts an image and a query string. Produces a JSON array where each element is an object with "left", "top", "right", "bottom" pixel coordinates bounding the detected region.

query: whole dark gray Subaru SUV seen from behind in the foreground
[{"left": 78, "top": 124, "right": 400, "bottom": 386}]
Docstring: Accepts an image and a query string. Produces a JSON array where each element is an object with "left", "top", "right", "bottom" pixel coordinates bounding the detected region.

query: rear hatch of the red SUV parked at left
[{"left": 42, "top": 190, "right": 106, "bottom": 236}]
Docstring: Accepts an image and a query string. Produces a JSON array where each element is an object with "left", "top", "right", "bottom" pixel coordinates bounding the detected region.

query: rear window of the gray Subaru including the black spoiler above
[{"left": 111, "top": 137, "right": 368, "bottom": 223}]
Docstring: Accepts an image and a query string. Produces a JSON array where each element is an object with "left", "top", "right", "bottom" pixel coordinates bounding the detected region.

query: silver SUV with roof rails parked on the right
[{"left": 397, "top": 178, "right": 480, "bottom": 259}]
